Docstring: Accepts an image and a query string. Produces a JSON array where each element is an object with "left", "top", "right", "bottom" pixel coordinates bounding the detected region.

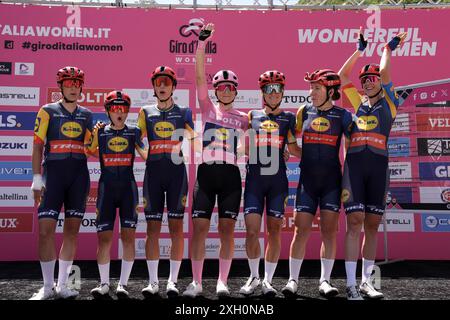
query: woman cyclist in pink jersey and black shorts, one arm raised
[{"left": 183, "top": 23, "right": 248, "bottom": 298}]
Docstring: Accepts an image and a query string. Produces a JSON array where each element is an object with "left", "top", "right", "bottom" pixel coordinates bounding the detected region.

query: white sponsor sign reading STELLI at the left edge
[{"left": 0, "top": 87, "right": 39, "bottom": 107}]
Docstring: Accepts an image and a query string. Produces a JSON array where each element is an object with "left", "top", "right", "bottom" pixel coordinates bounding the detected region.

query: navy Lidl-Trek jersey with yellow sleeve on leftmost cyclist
[{"left": 34, "top": 102, "right": 93, "bottom": 163}]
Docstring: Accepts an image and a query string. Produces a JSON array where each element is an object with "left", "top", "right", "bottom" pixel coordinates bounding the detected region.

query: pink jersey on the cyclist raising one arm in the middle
[{"left": 197, "top": 84, "right": 248, "bottom": 164}]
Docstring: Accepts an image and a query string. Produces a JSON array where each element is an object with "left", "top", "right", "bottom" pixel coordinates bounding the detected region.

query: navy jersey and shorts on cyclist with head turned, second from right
[{"left": 295, "top": 105, "right": 352, "bottom": 214}]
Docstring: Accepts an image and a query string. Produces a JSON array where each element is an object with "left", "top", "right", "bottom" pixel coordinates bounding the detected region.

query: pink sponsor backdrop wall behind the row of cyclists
[{"left": 0, "top": 4, "right": 450, "bottom": 260}]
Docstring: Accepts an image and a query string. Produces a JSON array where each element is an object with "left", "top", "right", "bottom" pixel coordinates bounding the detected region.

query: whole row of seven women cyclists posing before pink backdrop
[{"left": 31, "top": 23, "right": 406, "bottom": 300}]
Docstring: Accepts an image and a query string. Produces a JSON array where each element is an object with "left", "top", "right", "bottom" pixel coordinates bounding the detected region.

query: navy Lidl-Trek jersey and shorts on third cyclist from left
[{"left": 138, "top": 104, "right": 196, "bottom": 221}]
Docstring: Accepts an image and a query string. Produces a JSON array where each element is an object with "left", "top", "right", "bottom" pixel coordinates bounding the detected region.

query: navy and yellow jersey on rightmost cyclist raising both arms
[{"left": 343, "top": 82, "right": 399, "bottom": 157}]
